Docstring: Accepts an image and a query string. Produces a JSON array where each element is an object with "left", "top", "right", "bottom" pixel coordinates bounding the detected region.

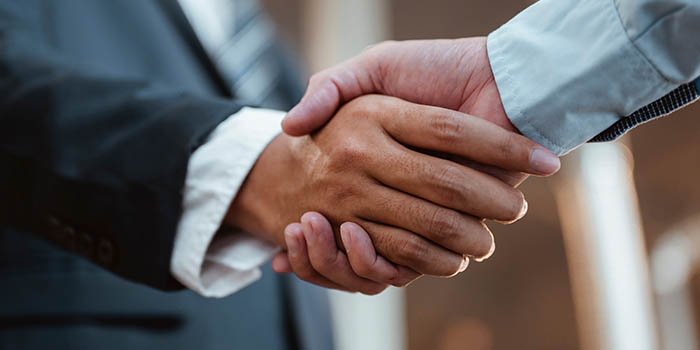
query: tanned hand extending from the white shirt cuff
[{"left": 226, "top": 95, "right": 555, "bottom": 288}]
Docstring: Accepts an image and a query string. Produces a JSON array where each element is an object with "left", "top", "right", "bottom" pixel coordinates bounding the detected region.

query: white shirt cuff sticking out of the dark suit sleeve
[{"left": 170, "top": 107, "right": 285, "bottom": 298}]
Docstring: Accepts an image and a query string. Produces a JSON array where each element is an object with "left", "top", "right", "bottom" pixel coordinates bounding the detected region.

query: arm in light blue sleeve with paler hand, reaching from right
[{"left": 283, "top": 0, "right": 700, "bottom": 154}]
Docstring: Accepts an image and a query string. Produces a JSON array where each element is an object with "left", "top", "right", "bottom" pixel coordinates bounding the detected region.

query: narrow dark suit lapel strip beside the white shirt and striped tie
[{"left": 155, "top": 0, "right": 233, "bottom": 97}]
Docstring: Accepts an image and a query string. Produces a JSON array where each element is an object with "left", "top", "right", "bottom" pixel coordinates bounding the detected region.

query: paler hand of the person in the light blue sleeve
[{"left": 272, "top": 37, "right": 559, "bottom": 291}]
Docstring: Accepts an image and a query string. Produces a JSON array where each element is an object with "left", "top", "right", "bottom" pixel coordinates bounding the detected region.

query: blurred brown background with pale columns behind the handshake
[{"left": 263, "top": 0, "right": 700, "bottom": 350}]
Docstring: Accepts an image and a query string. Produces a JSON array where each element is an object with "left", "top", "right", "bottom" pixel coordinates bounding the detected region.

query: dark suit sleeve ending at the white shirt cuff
[{"left": 0, "top": 21, "right": 239, "bottom": 289}]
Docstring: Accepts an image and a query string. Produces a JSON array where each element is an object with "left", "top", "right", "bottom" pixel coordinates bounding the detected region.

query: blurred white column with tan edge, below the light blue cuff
[{"left": 554, "top": 142, "right": 659, "bottom": 350}]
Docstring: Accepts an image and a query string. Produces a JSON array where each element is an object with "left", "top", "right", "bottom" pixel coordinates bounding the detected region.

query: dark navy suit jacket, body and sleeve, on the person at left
[{"left": 0, "top": 0, "right": 331, "bottom": 349}]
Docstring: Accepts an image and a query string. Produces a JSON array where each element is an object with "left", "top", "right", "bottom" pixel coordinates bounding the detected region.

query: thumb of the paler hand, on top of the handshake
[{"left": 282, "top": 55, "right": 381, "bottom": 136}]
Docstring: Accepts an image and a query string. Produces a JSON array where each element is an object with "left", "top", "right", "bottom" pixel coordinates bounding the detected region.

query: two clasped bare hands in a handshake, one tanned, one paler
[{"left": 225, "top": 38, "right": 560, "bottom": 294}]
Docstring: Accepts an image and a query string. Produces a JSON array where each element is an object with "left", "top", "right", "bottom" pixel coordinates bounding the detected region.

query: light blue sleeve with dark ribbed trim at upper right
[{"left": 487, "top": 0, "right": 700, "bottom": 154}]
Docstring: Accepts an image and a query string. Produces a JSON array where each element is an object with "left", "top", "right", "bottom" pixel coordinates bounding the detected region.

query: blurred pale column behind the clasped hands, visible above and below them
[{"left": 303, "top": 0, "right": 406, "bottom": 350}]
